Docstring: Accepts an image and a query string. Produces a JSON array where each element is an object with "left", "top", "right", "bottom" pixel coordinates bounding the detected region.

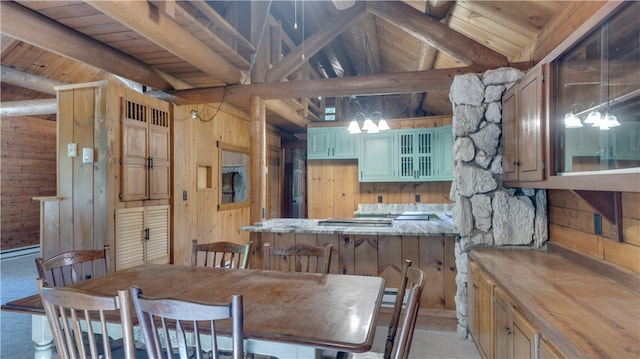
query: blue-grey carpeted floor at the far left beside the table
[{"left": 0, "top": 250, "right": 38, "bottom": 359}]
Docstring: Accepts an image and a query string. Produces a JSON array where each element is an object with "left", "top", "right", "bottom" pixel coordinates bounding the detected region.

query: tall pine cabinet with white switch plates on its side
[{"left": 41, "top": 81, "right": 171, "bottom": 263}]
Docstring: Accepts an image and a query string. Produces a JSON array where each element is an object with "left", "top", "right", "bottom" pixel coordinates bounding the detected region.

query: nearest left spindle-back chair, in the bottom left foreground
[{"left": 37, "top": 279, "right": 141, "bottom": 359}]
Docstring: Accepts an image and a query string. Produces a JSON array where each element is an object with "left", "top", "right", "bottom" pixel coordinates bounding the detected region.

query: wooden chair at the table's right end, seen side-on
[{"left": 338, "top": 260, "right": 425, "bottom": 359}]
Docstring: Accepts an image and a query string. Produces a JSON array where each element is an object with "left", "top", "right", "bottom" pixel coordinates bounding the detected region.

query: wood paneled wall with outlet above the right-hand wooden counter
[{"left": 549, "top": 190, "right": 640, "bottom": 273}]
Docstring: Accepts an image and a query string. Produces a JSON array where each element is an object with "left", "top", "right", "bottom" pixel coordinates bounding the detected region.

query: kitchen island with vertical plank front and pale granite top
[{"left": 240, "top": 212, "right": 457, "bottom": 330}]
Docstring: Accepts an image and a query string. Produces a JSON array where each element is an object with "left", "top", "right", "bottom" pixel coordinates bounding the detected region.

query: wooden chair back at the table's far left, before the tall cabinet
[{"left": 35, "top": 245, "right": 113, "bottom": 287}]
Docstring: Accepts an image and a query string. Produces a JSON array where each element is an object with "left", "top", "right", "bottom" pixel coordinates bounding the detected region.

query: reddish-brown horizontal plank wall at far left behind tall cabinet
[{"left": 0, "top": 117, "right": 56, "bottom": 250}]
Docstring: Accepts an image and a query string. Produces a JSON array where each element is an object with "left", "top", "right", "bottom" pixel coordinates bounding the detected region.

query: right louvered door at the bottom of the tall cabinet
[{"left": 145, "top": 205, "right": 170, "bottom": 264}]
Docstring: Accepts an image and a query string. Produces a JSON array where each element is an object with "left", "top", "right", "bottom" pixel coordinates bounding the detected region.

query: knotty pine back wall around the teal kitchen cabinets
[{"left": 307, "top": 116, "right": 452, "bottom": 218}]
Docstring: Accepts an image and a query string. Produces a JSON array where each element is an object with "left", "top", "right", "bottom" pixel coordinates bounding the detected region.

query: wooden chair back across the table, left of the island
[{"left": 191, "top": 239, "right": 252, "bottom": 269}]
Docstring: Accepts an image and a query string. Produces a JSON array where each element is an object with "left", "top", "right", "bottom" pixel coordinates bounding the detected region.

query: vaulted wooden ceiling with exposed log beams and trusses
[{"left": 0, "top": 0, "right": 581, "bottom": 132}]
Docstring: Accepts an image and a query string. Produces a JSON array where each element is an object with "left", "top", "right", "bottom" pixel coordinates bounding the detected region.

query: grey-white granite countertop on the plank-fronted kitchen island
[{"left": 240, "top": 212, "right": 458, "bottom": 236}]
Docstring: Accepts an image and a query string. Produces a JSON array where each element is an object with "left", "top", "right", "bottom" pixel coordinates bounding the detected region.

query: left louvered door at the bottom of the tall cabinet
[{"left": 115, "top": 207, "right": 145, "bottom": 270}]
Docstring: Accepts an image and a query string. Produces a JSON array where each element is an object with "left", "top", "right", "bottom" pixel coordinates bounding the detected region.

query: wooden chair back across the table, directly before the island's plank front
[{"left": 263, "top": 243, "right": 333, "bottom": 274}]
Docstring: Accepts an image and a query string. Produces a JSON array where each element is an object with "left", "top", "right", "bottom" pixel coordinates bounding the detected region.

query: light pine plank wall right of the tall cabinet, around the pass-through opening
[{"left": 172, "top": 103, "right": 280, "bottom": 264}]
